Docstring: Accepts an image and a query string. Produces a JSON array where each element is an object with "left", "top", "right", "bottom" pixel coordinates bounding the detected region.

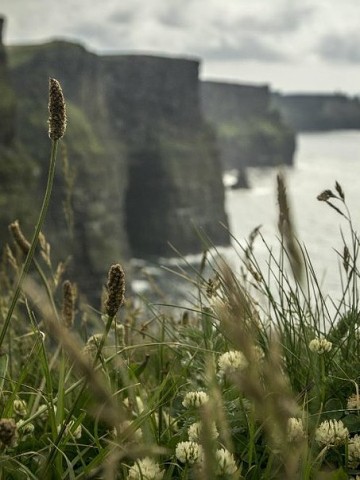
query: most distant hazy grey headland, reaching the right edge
[{"left": 273, "top": 94, "right": 360, "bottom": 132}]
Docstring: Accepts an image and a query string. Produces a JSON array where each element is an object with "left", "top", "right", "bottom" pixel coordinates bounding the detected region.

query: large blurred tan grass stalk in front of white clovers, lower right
[{"left": 219, "top": 268, "right": 303, "bottom": 480}]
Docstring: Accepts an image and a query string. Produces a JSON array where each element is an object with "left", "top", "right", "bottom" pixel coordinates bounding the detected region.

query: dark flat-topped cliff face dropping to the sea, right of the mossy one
[{"left": 100, "top": 56, "right": 229, "bottom": 257}]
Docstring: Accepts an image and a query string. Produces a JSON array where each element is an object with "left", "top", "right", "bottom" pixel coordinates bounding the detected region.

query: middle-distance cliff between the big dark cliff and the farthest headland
[{"left": 201, "top": 82, "right": 295, "bottom": 170}]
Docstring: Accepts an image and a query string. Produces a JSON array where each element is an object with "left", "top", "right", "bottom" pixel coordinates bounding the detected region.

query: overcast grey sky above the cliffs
[{"left": 0, "top": 0, "right": 360, "bottom": 94}]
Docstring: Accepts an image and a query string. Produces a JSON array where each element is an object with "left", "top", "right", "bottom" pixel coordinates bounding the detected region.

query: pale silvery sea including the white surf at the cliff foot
[{"left": 133, "top": 131, "right": 360, "bottom": 304}]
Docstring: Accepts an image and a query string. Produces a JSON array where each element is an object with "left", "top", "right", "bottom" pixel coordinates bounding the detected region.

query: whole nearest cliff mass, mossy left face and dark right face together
[{"left": 1, "top": 42, "right": 229, "bottom": 292}]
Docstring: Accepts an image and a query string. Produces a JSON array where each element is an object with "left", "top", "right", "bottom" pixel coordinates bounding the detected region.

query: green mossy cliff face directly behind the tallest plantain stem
[{"left": 9, "top": 42, "right": 129, "bottom": 296}]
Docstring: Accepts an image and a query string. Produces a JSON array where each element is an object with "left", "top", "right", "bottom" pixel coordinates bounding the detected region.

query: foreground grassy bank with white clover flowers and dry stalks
[{"left": 0, "top": 79, "right": 360, "bottom": 480}]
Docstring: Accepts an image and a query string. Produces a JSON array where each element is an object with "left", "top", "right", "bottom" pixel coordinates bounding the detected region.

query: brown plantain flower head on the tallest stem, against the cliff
[{"left": 48, "top": 78, "right": 66, "bottom": 141}]
